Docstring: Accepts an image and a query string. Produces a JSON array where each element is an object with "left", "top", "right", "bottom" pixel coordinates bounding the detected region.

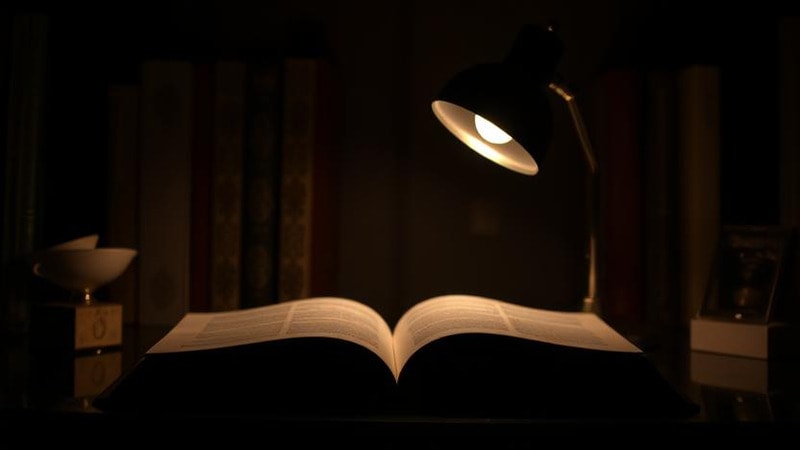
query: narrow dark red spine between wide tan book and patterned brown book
[{"left": 189, "top": 62, "right": 214, "bottom": 311}]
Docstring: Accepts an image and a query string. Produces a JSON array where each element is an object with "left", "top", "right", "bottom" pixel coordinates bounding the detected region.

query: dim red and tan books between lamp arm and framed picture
[{"left": 589, "top": 65, "right": 722, "bottom": 339}]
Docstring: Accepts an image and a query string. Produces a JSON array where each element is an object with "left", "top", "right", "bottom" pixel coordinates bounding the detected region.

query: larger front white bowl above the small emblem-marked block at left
[{"left": 33, "top": 247, "right": 137, "bottom": 294}]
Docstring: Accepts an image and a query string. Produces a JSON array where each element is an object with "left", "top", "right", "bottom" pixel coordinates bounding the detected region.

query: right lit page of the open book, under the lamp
[{"left": 394, "top": 295, "right": 641, "bottom": 369}]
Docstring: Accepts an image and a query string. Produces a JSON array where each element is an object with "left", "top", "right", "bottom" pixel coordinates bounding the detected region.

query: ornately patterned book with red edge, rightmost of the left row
[{"left": 278, "top": 58, "right": 338, "bottom": 301}]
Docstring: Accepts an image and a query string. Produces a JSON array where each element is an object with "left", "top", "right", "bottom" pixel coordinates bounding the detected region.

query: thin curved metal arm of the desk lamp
[{"left": 548, "top": 83, "right": 600, "bottom": 314}]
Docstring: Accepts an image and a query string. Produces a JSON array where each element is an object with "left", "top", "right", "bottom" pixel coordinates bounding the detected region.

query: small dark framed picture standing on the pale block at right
[{"left": 699, "top": 226, "right": 793, "bottom": 323}]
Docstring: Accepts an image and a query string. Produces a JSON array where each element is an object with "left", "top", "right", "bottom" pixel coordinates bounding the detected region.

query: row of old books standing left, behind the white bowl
[{"left": 107, "top": 58, "right": 340, "bottom": 325}]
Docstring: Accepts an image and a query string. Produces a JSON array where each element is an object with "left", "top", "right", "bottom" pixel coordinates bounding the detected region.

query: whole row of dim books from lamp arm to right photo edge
[{"left": 588, "top": 18, "right": 800, "bottom": 342}]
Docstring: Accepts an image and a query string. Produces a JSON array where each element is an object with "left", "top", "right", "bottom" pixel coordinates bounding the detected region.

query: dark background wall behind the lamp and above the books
[{"left": 2, "top": 0, "right": 794, "bottom": 334}]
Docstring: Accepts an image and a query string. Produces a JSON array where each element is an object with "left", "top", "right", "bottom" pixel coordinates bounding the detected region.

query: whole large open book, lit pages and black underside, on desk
[{"left": 95, "top": 295, "right": 693, "bottom": 418}]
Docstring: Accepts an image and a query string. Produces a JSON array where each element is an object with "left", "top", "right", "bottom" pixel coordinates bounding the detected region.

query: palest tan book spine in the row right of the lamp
[{"left": 678, "top": 65, "right": 720, "bottom": 327}]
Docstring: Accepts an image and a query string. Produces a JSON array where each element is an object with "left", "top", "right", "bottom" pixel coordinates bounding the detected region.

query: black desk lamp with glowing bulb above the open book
[{"left": 431, "top": 25, "right": 600, "bottom": 313}]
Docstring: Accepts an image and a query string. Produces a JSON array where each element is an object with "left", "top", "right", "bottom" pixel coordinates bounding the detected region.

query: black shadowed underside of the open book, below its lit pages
[{"left": 94, "top": 334, "right": 697, "bottom": 420}]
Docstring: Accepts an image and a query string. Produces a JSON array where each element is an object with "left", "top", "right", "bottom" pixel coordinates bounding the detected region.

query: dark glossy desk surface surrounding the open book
[{"left": 0, "top": 327, "right": 800, "bottom": 435}]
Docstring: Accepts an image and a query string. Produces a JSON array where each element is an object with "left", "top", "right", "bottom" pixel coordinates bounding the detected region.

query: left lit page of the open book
[{"left": 147, "top": 297, "right": 395, "bottom": 372}]
